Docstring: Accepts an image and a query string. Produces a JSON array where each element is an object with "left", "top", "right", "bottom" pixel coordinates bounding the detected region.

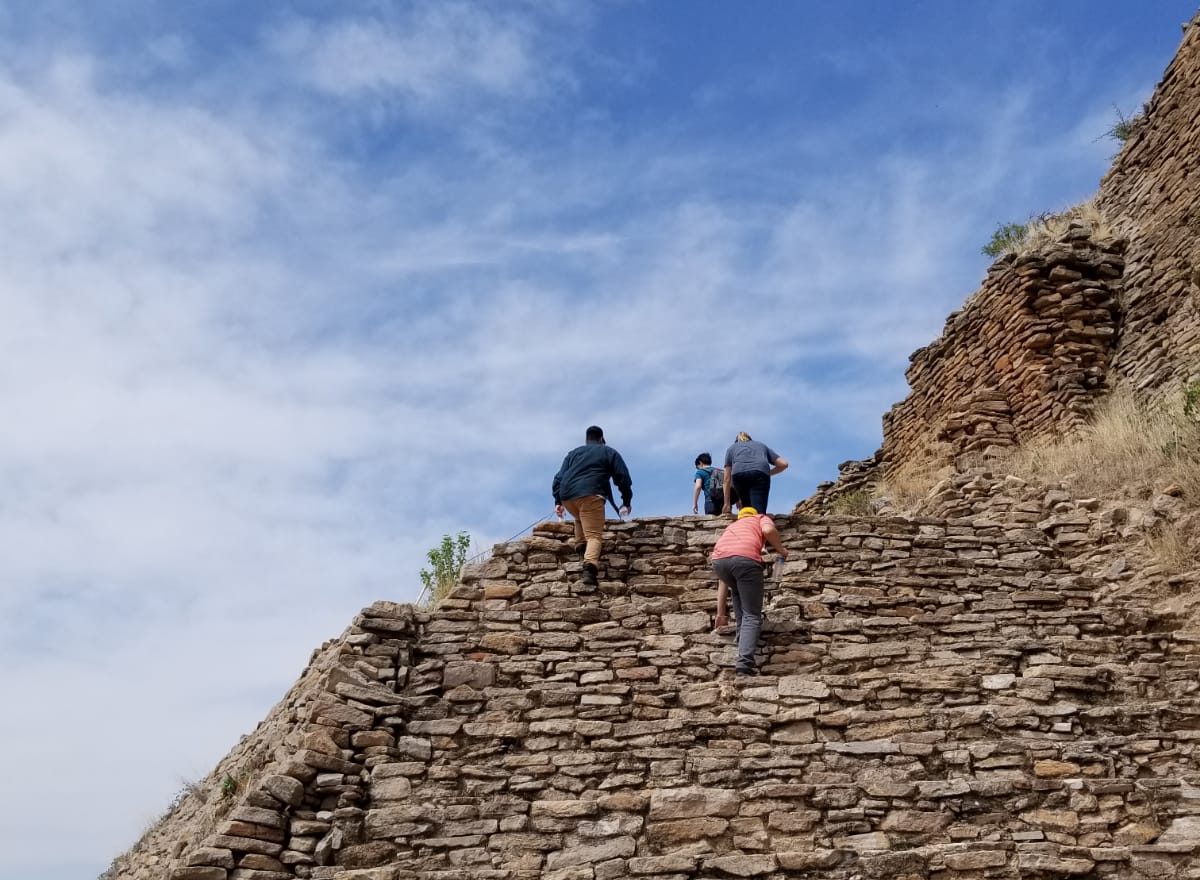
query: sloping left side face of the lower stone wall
[{"left": 103, "top": 619, "right": 415, "bottom": 880}]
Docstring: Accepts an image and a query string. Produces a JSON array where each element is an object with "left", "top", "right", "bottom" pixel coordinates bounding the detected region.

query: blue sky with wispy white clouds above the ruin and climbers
[{"left": 0, "top": 0, "right": 1196, "bottom": 880}]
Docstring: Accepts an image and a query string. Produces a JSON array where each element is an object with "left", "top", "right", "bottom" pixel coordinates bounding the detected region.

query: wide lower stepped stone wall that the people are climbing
[{"left": 130, "top": 511, "right": 1200, "bottom": 880}]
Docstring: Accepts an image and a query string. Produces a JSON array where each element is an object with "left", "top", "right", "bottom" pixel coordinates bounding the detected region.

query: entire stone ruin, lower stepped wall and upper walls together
[{"left": 106, "top": 17, "right": 1200, "bottom": 880}]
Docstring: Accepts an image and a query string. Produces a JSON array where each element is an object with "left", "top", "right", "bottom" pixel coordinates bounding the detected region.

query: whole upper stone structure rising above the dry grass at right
[{"left": 797, "top": 17, "right": 1200, "bottom": 513}]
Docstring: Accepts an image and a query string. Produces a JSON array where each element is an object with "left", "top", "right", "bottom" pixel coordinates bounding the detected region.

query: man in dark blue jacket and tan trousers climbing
[{"left": 553, "top": 425, "right": 634, "bottom": 587}]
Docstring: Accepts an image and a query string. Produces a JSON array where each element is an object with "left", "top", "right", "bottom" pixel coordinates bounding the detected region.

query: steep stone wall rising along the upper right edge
[{"left": 1098, "top": 16, "right": 1200, "bottom": 393}]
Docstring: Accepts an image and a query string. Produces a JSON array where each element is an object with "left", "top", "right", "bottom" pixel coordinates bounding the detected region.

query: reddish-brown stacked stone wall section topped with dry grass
[{"left": 883, "top": 230, "right": 1123, "bottom": 463}]
